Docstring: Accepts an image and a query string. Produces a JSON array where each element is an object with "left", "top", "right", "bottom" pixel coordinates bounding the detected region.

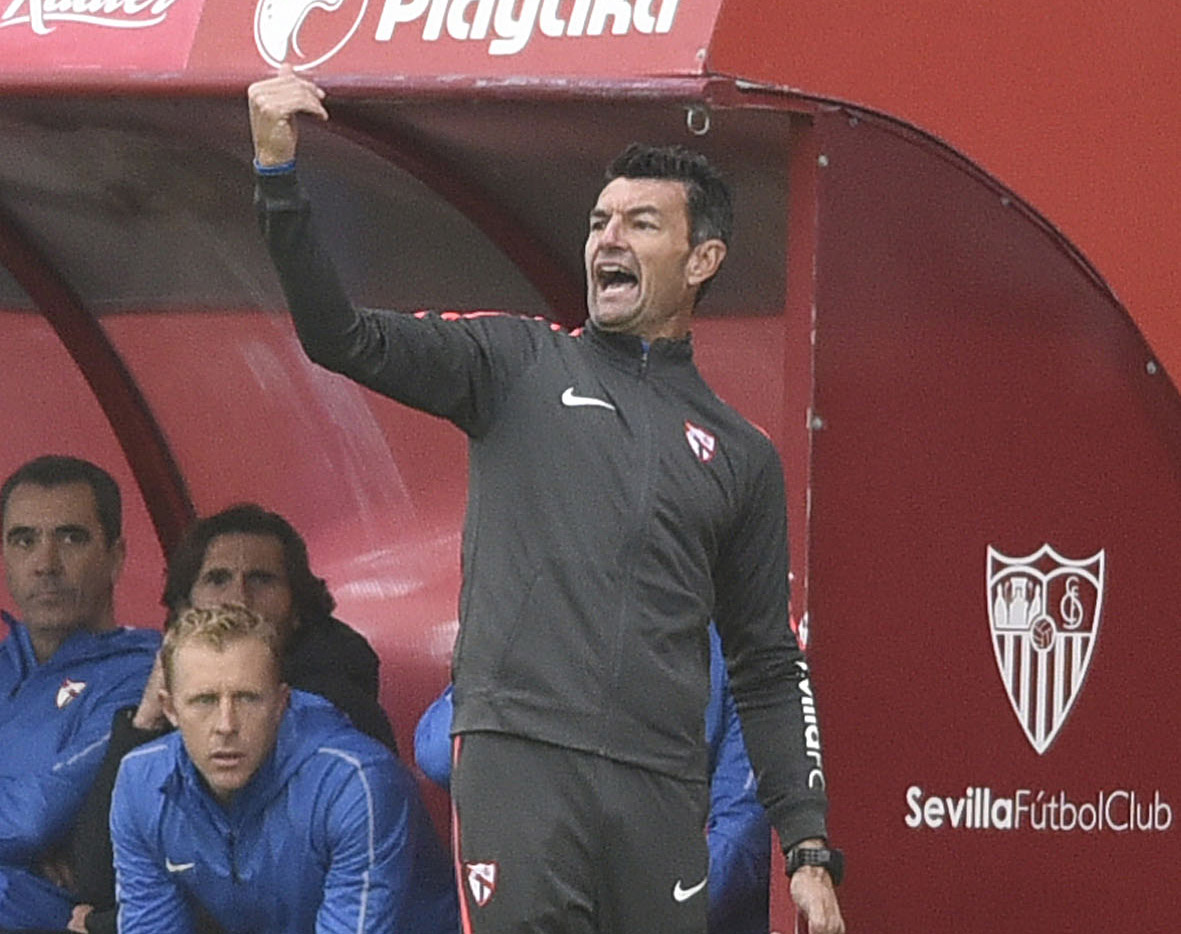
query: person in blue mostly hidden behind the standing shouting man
[{"left": 415, "top": 625, "right": 771, "bottom": 934}]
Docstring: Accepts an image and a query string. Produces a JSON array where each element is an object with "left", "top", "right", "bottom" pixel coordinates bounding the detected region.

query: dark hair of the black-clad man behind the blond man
[{"left": 161, "top": 503, "right": 337, "bottom": 620}]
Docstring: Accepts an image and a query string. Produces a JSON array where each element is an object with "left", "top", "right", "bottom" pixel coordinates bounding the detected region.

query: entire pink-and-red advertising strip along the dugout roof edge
[{"left": 0, "top": 0, "right": 722, "bottom": 83}]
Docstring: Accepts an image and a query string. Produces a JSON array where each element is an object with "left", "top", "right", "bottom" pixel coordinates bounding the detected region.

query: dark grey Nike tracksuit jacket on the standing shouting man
[{"left": 256, "top": 174, "right": 826, "bottom": 848}]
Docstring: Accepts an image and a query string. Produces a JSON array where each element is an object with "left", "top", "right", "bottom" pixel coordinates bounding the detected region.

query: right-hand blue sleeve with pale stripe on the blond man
[{"left": 315, "top": 751, "right": 417, "bottom": 934}]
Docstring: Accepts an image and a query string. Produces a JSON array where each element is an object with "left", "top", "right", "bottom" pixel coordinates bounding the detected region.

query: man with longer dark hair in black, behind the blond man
[{"left": 73, "top": 503, "right": 397, "bottom": 934}]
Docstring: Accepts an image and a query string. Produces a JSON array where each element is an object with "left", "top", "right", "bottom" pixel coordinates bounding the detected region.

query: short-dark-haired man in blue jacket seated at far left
[{"left": 0, "top": 455, "right": 159, "bottom": 930}]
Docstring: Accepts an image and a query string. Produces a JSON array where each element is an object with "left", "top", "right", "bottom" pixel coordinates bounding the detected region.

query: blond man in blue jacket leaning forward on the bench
[{"left": 111, "top": 606, "right": 458, "bottom": 934}]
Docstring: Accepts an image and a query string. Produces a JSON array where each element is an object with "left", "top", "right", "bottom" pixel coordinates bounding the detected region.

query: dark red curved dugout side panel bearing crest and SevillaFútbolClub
[{"left": 809, "top": 108, "right": 1181, "bottom": 934}]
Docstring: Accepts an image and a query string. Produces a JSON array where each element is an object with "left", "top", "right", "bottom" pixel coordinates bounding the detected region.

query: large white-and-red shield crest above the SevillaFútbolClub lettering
[{"left": 988, "top": 544, "right": 1104, "bottom": 755}]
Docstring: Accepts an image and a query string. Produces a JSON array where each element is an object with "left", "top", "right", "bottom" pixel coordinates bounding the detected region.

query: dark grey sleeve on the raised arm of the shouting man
[{"left": 255, "top": 172, "right": 540, "bottom": 437}]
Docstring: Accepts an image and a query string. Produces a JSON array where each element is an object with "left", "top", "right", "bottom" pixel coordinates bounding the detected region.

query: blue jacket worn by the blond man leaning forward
[{"left": 111, "top": 691, "right": 458, "bottom": 934}]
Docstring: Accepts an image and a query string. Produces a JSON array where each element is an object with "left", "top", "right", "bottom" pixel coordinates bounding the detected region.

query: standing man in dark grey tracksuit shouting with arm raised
[{"left": 249, "top": 66, "right": 843, "bottom": 934}]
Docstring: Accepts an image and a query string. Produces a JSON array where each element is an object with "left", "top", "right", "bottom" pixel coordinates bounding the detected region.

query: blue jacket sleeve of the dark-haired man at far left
[{"left": 0, "top": 660, "right": 150, "bottom": 863}]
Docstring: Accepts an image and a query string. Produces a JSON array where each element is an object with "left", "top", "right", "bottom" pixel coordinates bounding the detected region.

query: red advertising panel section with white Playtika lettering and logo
[{"left": 190, "top": 0, "right": 722, "bottom": 77}]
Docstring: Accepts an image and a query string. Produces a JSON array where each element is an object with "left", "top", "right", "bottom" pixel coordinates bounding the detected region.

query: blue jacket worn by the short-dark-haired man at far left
[{"left": 0, "top": 613, "right": 159, "bottom": 929}]
